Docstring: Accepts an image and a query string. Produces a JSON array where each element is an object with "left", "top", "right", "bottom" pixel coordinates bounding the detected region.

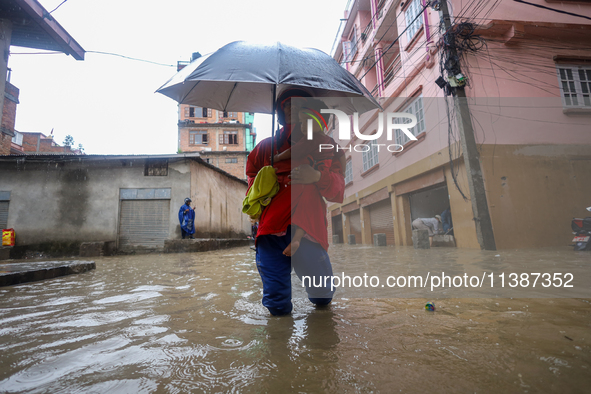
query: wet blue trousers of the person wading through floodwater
[{"left": 256, "top": 230, "right": 334, "bottom": 315}]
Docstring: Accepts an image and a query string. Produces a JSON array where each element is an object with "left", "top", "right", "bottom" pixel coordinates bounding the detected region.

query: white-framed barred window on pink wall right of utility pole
[{"left": 557, "top": 65, "right": 591, "bottom": 108}]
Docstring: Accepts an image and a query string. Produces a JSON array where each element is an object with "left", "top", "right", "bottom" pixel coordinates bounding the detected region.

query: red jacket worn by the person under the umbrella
[{"left": 246, "top": 126, "right": 345, "bottom": 250}]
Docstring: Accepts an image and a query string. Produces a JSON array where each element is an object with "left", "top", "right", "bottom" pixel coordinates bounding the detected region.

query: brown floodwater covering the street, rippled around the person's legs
[{"left": 0, "top": 245, "right": 591, "bottom": 393}]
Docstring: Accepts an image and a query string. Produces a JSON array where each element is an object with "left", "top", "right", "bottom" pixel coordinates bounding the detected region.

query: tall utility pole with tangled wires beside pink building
[{"left": 441, "top": 0, "right": 497, "bottom": 250}]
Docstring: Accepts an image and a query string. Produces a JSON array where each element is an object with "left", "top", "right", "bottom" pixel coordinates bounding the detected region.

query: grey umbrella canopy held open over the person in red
[{"left": 157, "top": 41, "right": 381, "bottom": 113}]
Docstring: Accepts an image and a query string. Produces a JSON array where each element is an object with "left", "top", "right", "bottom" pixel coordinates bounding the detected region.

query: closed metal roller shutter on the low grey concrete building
[{"left": 119, "top": 200, "right": 170, "bottom": 249}]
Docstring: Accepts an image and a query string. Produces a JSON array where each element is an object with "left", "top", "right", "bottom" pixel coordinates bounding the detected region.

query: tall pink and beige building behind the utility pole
[{"left": 328, "top": 0, "right": 591, "bottom": 249}]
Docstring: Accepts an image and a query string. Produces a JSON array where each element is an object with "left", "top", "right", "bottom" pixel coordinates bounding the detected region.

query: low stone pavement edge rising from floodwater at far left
[{"left": 0, "top": 260, "right": 96, "bottom": 287}]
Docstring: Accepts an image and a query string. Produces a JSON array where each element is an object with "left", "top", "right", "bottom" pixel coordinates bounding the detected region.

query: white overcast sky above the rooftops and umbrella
[{"left": 8, "top": 0, "right": 347, "bottom": 154}]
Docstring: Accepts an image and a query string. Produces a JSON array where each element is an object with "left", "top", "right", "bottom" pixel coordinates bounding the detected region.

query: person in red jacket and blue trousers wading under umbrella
[{"left": 246, "top": 89, "right": 345, "bottom": 315}]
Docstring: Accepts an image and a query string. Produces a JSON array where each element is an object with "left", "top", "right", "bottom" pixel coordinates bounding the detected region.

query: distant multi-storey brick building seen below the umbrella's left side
[{"left": 177, "top": 53, "right": 256, "bottom": 179}]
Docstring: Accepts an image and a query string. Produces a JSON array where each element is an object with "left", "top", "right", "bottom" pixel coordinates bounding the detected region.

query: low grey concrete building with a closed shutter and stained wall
[{"left": 0, "top": 153, "right": 250, "bottom": 251}]
